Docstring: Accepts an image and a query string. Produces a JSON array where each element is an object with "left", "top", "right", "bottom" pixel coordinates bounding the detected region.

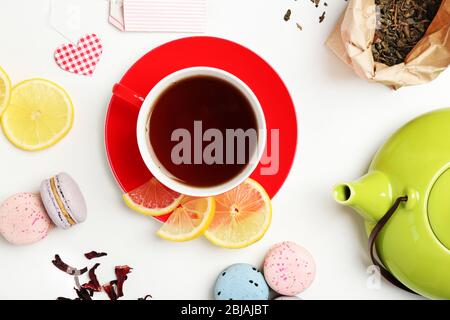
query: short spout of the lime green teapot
[{"left": 333, "top": 171, "right": 393, "bottom": 223}]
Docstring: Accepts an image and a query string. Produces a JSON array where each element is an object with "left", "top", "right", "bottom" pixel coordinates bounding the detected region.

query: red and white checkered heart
[{"left": 55, "top": 34, "right": 103, "bottom": 76}]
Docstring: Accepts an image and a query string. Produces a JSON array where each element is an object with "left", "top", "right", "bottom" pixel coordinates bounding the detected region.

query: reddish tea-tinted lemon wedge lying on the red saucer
[{"left": 123, "top": 178, "right": 183, "bottom": 217}]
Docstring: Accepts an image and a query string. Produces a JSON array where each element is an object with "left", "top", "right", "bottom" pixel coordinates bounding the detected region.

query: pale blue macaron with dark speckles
[{"left": 214, "top": 263, "right": 269, "bottom": 300}]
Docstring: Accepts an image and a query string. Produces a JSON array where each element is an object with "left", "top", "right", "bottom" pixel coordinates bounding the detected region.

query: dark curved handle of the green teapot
[{"left": 369, "top": 196, "right": 417, "bottom": 294}]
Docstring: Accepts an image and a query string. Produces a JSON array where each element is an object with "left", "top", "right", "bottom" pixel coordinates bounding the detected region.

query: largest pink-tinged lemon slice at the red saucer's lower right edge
[{"left": 205, "top": 179, "right": 272, "bottom": 249}]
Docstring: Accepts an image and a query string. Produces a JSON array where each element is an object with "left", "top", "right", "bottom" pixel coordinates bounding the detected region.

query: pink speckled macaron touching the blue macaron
[{"left": 264, "top": 242, "right": 316, "bottom": 296}]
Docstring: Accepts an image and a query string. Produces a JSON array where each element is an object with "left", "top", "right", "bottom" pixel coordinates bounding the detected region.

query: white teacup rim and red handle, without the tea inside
[{"left": 113, "top": 67, "right": 267, "bottom": 197}]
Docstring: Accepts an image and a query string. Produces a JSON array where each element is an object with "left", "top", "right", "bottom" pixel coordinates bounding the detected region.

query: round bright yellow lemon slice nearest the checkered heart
[{"left": 2, "top": 79, "right": 73, "bottom": 151}]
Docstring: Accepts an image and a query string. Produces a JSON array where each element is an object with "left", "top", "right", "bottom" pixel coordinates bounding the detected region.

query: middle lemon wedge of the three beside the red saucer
[{"left": 156, "top": 196, "right": 215, "bottom": 241}]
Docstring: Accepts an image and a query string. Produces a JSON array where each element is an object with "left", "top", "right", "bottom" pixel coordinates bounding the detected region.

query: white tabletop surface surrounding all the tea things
[{"left": 0, "top": 0, "right": 450, "bottom": 299}]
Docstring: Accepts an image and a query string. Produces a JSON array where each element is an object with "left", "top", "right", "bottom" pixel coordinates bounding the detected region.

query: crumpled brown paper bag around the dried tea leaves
[{"left": 327, "top": 0, "right": 450, "bottom": 89}]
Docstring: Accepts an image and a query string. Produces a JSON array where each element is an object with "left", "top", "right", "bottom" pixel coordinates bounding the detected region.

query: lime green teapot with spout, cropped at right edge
[{"left": 334, "top": 109, "right": 450, "bottom": 299}]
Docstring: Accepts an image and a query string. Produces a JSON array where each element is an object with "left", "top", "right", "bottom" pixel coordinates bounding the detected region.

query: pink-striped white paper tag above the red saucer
[{"left": 123, "top": 0, "right": 206, "bottom": 33}]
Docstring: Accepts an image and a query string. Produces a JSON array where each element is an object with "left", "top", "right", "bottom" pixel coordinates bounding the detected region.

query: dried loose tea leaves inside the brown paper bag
[{"left": 372, "top": 0, "right": 442, "bottom": 66}]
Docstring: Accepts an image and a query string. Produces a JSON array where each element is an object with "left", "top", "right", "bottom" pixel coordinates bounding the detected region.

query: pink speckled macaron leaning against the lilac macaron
[{"left": 0, "top": 193, "right": 52, "bottom": 245}]
